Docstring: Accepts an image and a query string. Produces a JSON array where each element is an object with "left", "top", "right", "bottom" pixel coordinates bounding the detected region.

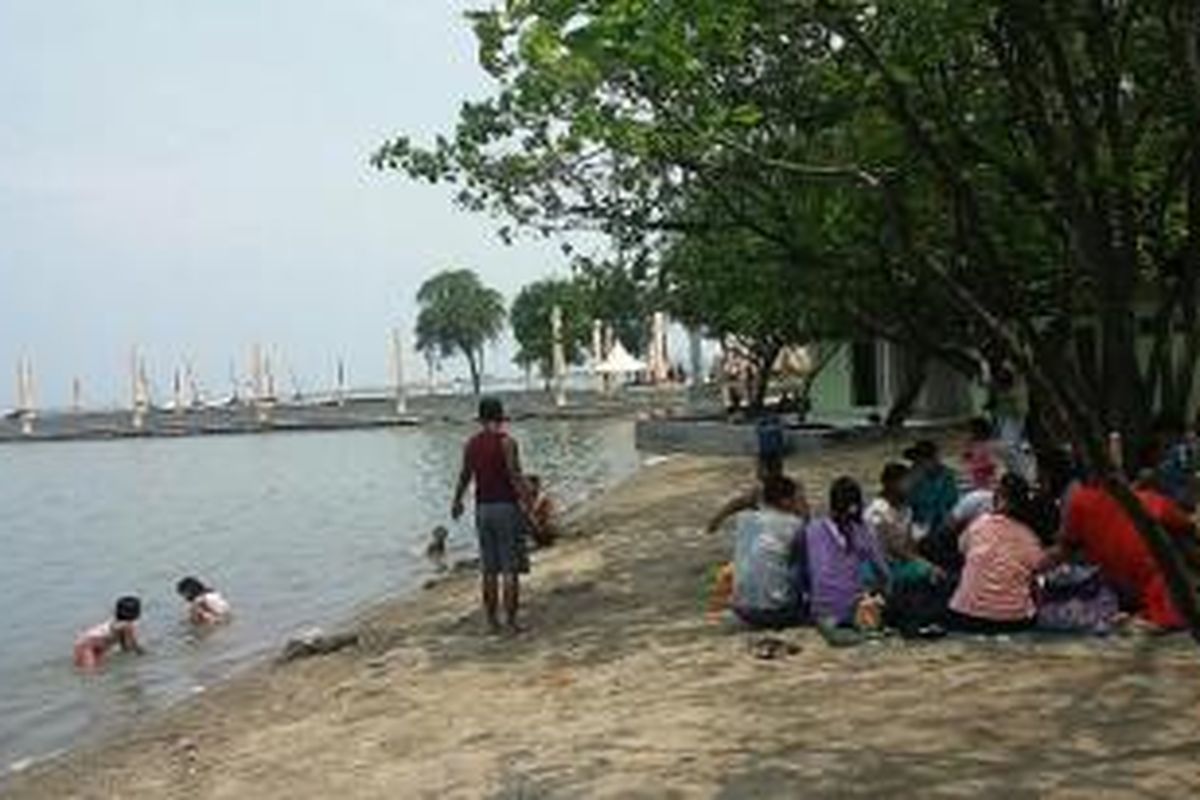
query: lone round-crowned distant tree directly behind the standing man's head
[{"left": 416, "top": 270, "right": 505, "bottom": 395}]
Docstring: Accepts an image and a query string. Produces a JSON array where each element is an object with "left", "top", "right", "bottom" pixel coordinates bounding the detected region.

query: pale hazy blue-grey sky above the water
[{"left": 0, "top": 0, "right": 565, "bottom": 408}]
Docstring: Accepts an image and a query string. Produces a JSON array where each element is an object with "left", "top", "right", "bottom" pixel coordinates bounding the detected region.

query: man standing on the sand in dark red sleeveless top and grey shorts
[{"left": 450, "top": 397, "right": 529, "bottom": 633}]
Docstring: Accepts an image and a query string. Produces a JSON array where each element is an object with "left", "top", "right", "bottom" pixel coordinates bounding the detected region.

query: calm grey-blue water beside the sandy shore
[{"left": 0, "top": 422, "right": 637, "bottom": 774}]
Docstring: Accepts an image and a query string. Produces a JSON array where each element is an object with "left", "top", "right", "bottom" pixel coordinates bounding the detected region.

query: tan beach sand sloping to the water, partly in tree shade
[{"left": 6, "top": 443, "right": 1200, "bottom": 800}]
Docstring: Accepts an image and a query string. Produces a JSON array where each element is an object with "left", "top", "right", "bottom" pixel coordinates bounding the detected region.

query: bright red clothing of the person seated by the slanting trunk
[{"left": 1061, "top": 474, "right": 1195, "bottom": 628}]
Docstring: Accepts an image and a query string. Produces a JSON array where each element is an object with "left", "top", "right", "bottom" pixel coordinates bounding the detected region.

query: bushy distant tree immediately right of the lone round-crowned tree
[{"left": 509, "top": 278, "right": 593, "bottom": 380}]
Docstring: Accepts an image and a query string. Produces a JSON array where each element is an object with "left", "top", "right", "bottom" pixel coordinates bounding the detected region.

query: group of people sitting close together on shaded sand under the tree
[{"left": 708, "top": 420, "right": 1200, "bottom": 640}]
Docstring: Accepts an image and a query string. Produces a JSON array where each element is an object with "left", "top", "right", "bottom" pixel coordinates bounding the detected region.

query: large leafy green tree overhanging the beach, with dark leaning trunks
[{"left": 376, "top": 0, "right": 1200, "bottom": 633}]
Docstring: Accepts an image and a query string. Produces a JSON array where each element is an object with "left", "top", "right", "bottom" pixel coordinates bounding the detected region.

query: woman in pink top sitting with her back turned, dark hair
[{"left": 949, "top": 474, "right": 1046, "bottom": 633}]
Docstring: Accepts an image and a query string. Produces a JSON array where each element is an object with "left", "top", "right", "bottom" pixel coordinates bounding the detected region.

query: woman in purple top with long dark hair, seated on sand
[{"left": 805, "top": 476, "right": 890, "bottom": 625}]
